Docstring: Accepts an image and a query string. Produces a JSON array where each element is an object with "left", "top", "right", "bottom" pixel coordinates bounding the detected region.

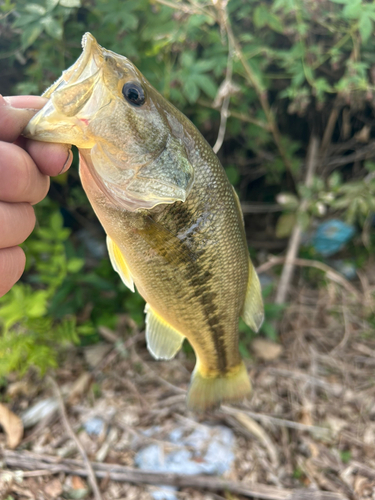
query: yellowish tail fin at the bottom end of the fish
[{"left": 187, "top": 362, "right": 251, "bottom": 411}]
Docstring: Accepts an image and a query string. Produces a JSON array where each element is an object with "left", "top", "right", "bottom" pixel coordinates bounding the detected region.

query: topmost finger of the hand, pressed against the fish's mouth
[{"left": 0, "top": 95, "right": 47, "bottom": 142}]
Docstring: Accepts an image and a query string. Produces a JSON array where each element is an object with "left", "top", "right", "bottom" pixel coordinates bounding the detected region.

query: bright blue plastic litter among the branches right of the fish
[{"left": 312, "top": 219, "right": 355, "bottom": 257}]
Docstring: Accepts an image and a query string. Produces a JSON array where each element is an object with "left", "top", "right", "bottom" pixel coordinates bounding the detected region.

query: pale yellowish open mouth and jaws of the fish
[{"left": 23, "top": 33, "right": 107, "bottom": 148}]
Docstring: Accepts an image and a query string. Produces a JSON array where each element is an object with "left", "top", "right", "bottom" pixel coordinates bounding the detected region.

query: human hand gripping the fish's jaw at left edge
[{"left": 0, "top": 95, "right": 73, "bottom": 297}]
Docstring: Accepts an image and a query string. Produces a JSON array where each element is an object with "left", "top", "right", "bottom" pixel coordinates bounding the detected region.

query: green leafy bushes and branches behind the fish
[{"left": 0, "top": 0, "right": 375, "bottom": 376}]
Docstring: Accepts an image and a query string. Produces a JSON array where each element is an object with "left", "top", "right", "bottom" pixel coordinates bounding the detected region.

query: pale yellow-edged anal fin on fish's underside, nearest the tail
[{"left": 145, "top": 304, "right": 185, "bottom": 359}]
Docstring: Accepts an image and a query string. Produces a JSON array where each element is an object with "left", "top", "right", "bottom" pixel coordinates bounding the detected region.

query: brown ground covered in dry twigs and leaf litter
[{"left": 0, "top": 264, "right": 375, "bottom": 500}]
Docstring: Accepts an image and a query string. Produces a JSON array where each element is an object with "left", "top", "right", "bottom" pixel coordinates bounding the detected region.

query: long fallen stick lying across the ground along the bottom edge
[{"left": 0, "top": 450, "right": 348, "bottom": 500}]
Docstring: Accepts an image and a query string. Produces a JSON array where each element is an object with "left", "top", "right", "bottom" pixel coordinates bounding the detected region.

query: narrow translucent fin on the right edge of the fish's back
[{"left": 242, "top": 261, "right": 264, "bottom": 332}]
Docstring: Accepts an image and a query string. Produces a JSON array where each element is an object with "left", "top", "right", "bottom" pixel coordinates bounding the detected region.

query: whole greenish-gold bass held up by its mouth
[{"left": 23, "top": 33, "right": 264, "bottom": 411}]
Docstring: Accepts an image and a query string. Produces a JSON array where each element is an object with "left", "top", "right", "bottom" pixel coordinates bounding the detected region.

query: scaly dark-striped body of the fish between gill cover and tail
[{"left": 82, "top": 143, "right": 248, "bottom": 373}]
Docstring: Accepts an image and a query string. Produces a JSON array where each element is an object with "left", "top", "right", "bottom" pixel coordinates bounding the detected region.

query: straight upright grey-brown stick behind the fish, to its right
[{"left": 275, "top": 135, "right": 319, "bottom": 304}]
